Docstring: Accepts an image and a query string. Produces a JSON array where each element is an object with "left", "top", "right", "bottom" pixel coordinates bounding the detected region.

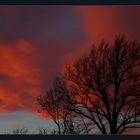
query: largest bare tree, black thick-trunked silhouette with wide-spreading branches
[{"left": 65, "top": 36, "right": 140, "bottom": 134}]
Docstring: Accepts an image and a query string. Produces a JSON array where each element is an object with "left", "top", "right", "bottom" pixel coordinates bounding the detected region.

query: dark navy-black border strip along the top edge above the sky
[{"left": 0, "top": 0, "right": 140, "bottom": 5}]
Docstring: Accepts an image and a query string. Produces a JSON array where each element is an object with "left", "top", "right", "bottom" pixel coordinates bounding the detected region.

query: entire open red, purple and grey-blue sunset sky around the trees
[{"left": 0, "top": 5, "right": 140, "bottom": 133}]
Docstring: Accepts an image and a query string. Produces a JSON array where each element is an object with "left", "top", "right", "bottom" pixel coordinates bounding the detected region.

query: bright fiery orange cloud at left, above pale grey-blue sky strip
[{"left": 0, "top": 39, "right": 46, "bottom": 112}]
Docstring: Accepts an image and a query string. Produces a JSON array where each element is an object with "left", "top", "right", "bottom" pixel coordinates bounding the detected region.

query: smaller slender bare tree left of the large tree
[{"left": 37, "top": 77, "right": 78, "bottom": 134}]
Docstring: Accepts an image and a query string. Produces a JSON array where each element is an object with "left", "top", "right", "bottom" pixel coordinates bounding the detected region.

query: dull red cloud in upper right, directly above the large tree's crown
[{"left": 75, "top": 6, "right": 140, "bottom": 44}]
